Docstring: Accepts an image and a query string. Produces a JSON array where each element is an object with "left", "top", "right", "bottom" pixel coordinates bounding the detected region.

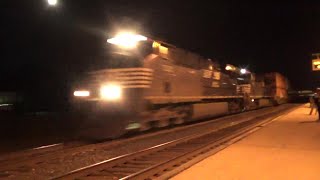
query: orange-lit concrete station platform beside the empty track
[{"left": 172, "top": 104, "right": 320, "bottom": 180}]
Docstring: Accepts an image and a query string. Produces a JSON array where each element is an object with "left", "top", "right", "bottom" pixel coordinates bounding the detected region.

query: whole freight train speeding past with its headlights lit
[{"left": 72, "top": 33, "right": 287, "bottom": 139}]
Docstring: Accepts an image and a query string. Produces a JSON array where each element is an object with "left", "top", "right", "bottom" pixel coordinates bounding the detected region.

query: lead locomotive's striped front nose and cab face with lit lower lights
[{"left": 73, "top": 36, "right": 152, "bottom": 107}]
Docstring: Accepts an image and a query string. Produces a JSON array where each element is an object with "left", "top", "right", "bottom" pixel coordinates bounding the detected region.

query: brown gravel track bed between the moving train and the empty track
[{"left": 0, "top": 105, "right": 295, "bottom": 179}]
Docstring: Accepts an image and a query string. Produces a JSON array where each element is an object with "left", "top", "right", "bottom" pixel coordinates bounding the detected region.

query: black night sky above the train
[{"left": 0, "top": 0, "right": 320, "bottom": 109}]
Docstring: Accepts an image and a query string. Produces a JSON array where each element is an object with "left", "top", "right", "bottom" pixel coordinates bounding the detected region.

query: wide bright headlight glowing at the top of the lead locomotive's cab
[{"left": 107, "top": 33, "right": 147, "bottom": 49}]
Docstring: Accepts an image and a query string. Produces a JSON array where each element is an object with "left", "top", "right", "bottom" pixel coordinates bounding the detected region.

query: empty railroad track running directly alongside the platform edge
[{"left": 53, "top": 105, "right": 298, "bottom": 179}]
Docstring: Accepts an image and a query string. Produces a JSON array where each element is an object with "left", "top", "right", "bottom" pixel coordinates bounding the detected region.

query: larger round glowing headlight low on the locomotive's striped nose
[{"left": 100, "top": 84, "right": 122, "bottom": 101}]
